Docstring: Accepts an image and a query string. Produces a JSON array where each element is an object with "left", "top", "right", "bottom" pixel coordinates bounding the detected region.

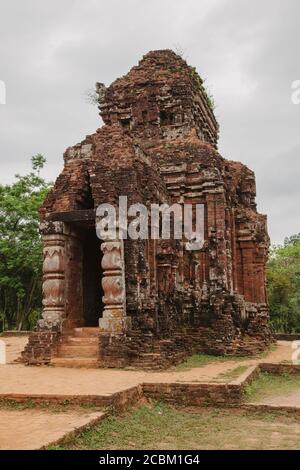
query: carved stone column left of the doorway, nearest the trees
[{"left": 42, "top": 222, "right": 65, "bottom": 325}]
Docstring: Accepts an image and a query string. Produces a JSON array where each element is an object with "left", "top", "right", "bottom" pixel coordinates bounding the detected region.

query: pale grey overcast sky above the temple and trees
[{"left": 0, "top": 0, "right": 300, "bottom": 243}]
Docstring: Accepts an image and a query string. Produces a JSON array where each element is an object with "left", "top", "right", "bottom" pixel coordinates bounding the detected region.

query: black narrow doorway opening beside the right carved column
[{"left": 82, "top": 228, "right": 103, "bottom": 326}]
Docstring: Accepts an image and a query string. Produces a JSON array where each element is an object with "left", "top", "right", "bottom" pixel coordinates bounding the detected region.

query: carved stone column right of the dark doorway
[{"left": 99, "top": 239, "right": 130, "bottom": 335}]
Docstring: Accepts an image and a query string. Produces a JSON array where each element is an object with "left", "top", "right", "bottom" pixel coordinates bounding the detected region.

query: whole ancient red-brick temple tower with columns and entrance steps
[{"left": 23, "top": 50, "right": 270, "bottom": 367}]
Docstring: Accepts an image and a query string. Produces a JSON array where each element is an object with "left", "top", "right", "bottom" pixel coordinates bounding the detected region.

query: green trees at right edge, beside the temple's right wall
[{"left": 267, "top": 234, "right": 300, "bottom": 333}]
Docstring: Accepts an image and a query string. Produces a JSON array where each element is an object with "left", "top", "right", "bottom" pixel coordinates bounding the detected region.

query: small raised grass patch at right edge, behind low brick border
[{"left": 245, "top": 372, "right": 300, "bottom": 402}]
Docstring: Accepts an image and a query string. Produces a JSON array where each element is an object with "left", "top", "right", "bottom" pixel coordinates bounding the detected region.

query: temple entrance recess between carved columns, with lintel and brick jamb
[{"left": 43, "top": 209, "right": 104, "bottom": 331}]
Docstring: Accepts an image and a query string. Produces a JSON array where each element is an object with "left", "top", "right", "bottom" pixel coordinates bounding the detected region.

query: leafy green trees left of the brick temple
[{"left": 0, "top": 154, "right": 50, "bottom": 330}]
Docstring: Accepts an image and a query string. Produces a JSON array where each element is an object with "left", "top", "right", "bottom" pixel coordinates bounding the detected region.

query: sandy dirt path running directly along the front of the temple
[{"left": 0, "top": 337, "right": 291, "bottom": 395}]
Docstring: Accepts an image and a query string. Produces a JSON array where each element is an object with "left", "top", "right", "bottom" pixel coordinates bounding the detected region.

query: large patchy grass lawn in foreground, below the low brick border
[{"left": 51, "top": 403, "right": 300, "bottom": 450}]
